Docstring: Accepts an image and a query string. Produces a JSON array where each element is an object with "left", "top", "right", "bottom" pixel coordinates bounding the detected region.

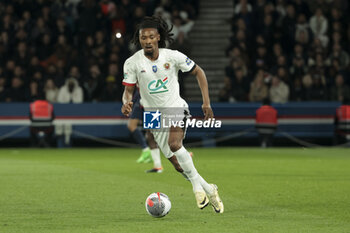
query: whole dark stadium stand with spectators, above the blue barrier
[{"left": 0, "top": 0, "right": 350, "bottom": 103}]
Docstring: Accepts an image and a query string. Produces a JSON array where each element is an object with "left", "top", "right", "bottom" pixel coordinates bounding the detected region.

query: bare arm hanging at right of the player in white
[{"left": 191, "top": 65, "right": 214, "bottom": 120}]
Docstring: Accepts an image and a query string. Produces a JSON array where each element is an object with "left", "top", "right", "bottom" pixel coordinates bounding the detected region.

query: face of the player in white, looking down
[{"left": 139, "top": 28, "right": 160, "bottom": 56}]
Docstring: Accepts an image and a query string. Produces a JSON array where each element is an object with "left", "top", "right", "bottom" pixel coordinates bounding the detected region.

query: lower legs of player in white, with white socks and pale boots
[{"left": 168, "top": 127, "right": 224, "bottom": 213}]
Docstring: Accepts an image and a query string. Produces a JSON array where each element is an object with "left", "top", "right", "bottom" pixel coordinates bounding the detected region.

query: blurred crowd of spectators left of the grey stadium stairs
[{"left": 0, "top": 0, "right": 198, "bottom": 103}]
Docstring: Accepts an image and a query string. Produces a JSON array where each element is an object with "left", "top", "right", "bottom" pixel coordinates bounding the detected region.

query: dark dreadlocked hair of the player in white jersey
[{"left": 132, "top": 16, "right": 174, "bottom": 48}]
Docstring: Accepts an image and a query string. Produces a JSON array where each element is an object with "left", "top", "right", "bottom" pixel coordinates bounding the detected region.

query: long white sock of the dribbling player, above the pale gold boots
[{"left": 174, "top": 147, "right": 204, "bottom": 192}]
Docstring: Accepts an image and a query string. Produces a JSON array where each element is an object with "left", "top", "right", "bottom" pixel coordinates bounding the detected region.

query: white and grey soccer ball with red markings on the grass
[{"left": 145, "top": 192, "right": 171, "bottom": 218}]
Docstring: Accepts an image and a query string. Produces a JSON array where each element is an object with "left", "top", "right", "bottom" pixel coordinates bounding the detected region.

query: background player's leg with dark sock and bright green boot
[{"left": 128, "top": 117, "right": 152, "bottom": 163}]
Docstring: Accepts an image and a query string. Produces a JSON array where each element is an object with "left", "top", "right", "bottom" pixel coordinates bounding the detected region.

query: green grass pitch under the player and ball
[{"left": 0, "top": 148, "right": 350, "bottom": 233}]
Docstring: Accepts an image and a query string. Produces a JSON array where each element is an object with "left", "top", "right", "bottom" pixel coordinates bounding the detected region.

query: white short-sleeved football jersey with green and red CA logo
[{"left": 123, "top": 48, "right": 195, "bottom": 109}]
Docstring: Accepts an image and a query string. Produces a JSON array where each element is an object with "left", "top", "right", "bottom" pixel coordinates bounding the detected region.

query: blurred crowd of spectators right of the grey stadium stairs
[{"left": 219, "top": 0, "right": 350, "bottom": 103}]
